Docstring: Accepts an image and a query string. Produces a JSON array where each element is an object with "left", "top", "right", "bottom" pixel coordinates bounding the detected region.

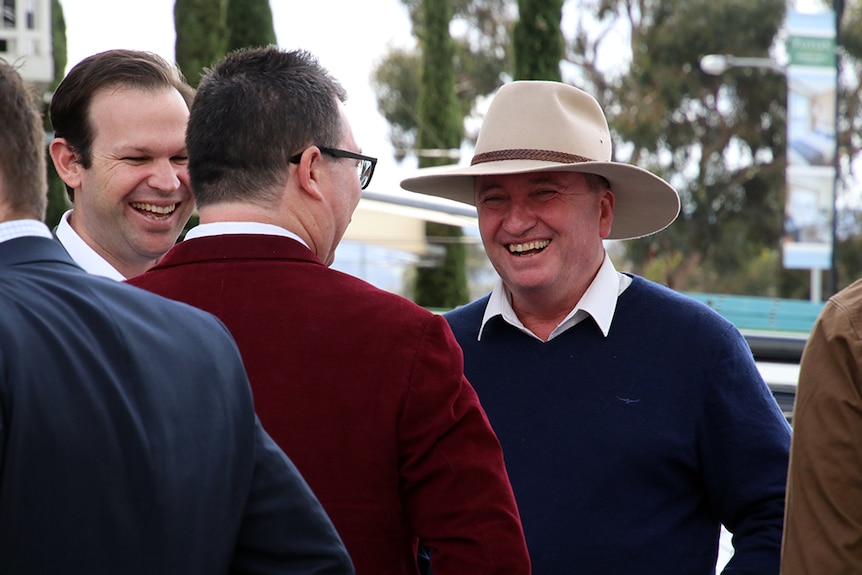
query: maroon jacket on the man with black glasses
[{"left": 129, "top": 235, "right": 530, "bottom": 575}]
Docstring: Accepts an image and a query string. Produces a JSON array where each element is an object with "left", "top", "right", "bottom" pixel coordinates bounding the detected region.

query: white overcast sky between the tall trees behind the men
[{"left": 60, "top": 0, "right": 422, "bottom": 191}]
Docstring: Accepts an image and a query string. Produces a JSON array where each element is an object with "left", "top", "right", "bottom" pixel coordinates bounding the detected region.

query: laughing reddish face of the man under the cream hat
[{"left": 474, "top": 172, "right": 614, "bottom": 305}]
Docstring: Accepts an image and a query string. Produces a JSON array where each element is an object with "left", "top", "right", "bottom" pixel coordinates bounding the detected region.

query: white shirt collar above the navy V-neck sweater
[{"left": 478, "top": 252, "right": 632, "bottom": 341}]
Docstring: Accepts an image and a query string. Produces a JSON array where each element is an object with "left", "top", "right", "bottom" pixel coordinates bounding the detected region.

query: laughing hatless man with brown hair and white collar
[{"left": 50, "top": 50, "right": 194, "bottom": 280}]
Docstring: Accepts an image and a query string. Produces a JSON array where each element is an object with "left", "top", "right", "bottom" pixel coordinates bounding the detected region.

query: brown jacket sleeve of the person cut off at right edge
[{"left": 781, "top": 288, "right": 862, "bottom": 575}]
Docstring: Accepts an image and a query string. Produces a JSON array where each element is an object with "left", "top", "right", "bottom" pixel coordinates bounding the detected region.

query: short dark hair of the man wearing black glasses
[{"left": 186, "top": 46, "right": 347, "bottom": 206}]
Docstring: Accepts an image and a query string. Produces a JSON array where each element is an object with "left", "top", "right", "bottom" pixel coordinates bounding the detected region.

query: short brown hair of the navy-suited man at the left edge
[{"left": 0, "top": 59, "right": 48, "bottom": 221}]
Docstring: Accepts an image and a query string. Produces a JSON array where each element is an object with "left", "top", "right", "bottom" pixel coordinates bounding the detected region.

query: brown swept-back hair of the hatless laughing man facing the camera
[{"left": 50, "top": 50, "right": 194, "bottom": 198}]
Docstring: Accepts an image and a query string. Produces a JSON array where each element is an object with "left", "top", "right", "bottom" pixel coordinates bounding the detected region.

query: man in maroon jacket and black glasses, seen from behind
[{"left": 131, "top": 47, "right": 530, "bottom": 575}]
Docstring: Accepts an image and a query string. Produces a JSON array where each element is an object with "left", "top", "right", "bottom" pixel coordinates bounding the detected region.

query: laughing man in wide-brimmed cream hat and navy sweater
[{"left": 401, "top": 81, "right": 790, "bottom": 575}]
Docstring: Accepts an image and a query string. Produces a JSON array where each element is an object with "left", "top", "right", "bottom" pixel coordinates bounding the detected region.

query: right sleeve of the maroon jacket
[{"left": 399, "top": 315, "right": 530, "bottom": 575}]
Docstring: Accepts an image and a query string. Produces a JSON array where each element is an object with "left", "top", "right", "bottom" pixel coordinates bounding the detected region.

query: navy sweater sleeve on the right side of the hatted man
[{"left": 700, "top": 326, "right": 790, "bottom": 574}]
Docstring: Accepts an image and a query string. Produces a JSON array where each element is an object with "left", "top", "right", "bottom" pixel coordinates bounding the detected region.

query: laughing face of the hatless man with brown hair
[{"left": 71, "top": 84, "right": 194, "bottom": 277}]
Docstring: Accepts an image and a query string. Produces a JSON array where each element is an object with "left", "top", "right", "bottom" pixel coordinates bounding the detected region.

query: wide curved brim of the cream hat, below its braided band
[{"left": 401, "top": 160, "right": 680, "bottom": 240}]
